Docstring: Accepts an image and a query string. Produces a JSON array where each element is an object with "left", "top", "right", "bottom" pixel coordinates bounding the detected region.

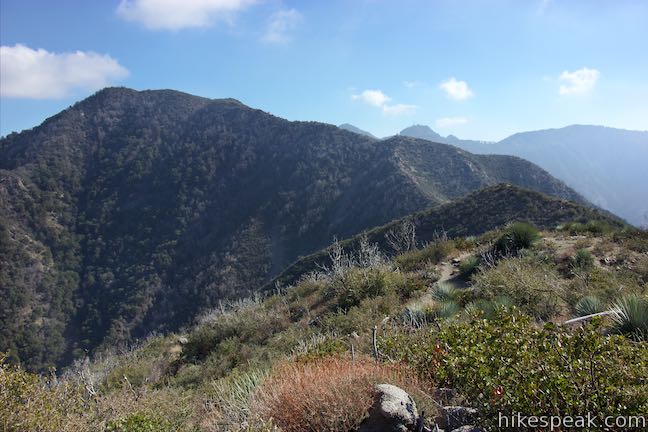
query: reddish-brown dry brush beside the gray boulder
[{"left": 252, "top": 357, "right": 420, "bottom": 432}]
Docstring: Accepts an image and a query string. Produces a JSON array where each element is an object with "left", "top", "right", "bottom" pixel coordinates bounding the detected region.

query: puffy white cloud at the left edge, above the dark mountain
[{"left": 0, "top": 44, "right": 128, "bottom": 99}]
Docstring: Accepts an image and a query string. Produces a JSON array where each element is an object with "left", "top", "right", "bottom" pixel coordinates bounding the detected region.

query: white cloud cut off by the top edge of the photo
[{"left": 117, "top": 0, "right": 256, "bottom": 30}]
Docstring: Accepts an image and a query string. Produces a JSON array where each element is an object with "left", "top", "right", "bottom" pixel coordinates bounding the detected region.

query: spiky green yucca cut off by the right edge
[{"left": 612, "top": 294, "right": 648, "bottom": 341}]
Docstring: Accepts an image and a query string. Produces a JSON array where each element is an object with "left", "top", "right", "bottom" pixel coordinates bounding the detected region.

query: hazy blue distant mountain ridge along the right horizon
[{"left": 401, "top": 125, "right": 648, "bottom": 225}]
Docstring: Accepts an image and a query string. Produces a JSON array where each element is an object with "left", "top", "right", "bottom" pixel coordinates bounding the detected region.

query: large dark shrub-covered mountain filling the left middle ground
[{"left": 0, "top": 88, "right": 582, "bottom": 369}]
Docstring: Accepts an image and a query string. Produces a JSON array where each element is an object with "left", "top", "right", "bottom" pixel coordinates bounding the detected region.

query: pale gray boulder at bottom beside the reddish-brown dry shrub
[{"left": 359, "top": 384, "right": 418, "bottom": 432}]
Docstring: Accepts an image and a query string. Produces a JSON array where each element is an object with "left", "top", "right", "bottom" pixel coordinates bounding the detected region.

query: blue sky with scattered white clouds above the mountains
[{"left": 0, "top": 0, "right": 648, "bottom": 140}]
